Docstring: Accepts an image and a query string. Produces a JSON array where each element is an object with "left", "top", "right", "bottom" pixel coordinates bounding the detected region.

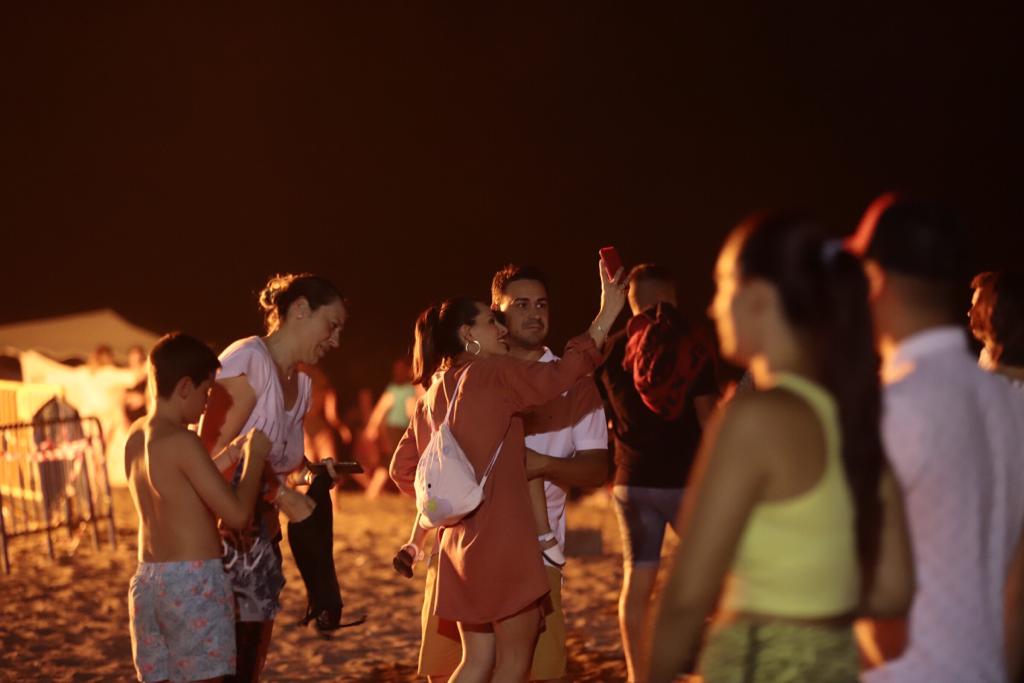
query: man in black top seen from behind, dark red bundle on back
[{"left": 594, "top": 263, "right": 719, "bottom": 682}]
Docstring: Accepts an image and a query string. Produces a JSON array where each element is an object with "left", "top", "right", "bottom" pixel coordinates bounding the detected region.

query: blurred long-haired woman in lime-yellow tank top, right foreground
[{"left": 648, "top": 214, "right": 913, "bottom": 683}]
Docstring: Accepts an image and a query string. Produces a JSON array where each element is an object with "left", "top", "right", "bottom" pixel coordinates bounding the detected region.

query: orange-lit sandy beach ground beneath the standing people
[{"left": 0, "top": 489, "right": 651, "bottom": 681}]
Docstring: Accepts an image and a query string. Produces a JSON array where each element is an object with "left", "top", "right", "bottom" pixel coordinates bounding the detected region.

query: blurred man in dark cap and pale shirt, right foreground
[{"left": 847, "top": 195, "right": 1024, "bottom": 683}]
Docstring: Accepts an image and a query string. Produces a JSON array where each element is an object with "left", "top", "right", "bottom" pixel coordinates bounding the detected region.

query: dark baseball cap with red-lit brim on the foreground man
[{"left": 844, "top": 193, "right": 971, "bottom": 282}]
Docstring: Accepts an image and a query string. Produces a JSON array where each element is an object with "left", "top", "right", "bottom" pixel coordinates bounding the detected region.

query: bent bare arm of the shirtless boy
[{"left": 175, "top": 429, "right": 270, "bottom": 528}]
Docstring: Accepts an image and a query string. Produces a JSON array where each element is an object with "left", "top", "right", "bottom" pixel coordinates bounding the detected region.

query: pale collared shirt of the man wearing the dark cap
[{"left": 864, "top": 327, "right": 1024, "bottom": 683}]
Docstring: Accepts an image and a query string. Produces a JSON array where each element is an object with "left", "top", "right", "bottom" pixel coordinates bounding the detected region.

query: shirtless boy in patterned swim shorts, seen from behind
[{"left": 125, "top": 333, "right": 270, "bottom": 683}]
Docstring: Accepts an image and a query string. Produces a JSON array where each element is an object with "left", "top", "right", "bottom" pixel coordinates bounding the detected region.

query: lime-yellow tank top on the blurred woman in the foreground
[{"left": 722, "top": 374, "right": 860, "bottom": 618}]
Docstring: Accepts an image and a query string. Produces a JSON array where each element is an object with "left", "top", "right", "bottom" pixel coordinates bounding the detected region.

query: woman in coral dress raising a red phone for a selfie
[{"left": 391, "top": 268, "right": 625, "bottom": 683}]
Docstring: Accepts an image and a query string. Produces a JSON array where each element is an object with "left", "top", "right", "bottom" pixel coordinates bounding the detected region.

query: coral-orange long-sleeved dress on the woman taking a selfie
[{"left": 391, "top": 335, "right": 601, "bottom": 624}]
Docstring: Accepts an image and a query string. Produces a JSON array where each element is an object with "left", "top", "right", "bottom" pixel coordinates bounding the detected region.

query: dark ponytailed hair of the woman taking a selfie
[{"left": 413, "top": 297, "right": 482, "bottom": 388}]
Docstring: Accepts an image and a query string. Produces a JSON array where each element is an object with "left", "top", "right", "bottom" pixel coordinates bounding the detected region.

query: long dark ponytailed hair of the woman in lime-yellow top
[{"left": 737, "top": 213, "right": 885, "bottom": 586}]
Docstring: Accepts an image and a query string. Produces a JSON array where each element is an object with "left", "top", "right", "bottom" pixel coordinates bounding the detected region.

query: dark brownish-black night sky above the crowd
[{"left": 0, "top": 1, "right": 1024, "bottom": 401}]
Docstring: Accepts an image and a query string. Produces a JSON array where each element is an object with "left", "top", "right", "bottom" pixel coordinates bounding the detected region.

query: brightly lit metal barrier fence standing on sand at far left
[{"left": 0, "top": 418, "right": 116, "bottom": 573}]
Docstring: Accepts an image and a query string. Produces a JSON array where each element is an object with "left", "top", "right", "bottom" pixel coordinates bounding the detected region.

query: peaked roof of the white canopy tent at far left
[{"left": 0, "top": 308, "right": 160, "bottom": 364}]
